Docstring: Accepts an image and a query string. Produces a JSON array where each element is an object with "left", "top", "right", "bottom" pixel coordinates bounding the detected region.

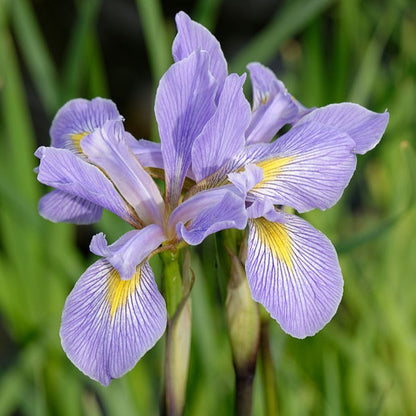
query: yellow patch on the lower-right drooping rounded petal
[{"left": 251, "top": 218, "right": 293, "bottom": 269}]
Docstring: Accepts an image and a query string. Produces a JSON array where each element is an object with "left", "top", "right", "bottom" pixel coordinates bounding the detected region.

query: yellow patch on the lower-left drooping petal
[{"left": 107, "top": 268, "right": 140, "bottom": 318}]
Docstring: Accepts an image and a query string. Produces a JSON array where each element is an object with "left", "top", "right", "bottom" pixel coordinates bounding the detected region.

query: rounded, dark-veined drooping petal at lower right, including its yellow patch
[{"left": 246, "top": 214, "right": 343, "bottom": 338}]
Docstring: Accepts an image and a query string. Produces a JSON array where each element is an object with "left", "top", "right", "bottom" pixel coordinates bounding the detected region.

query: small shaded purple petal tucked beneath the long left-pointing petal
[{"left": 39, "top": 189, "right": 103, "bottom": 224}]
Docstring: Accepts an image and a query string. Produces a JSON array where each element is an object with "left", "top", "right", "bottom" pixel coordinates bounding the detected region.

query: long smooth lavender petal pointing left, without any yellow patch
[{"left": 35, "top": 147, "right": 138, "bottom": 226}]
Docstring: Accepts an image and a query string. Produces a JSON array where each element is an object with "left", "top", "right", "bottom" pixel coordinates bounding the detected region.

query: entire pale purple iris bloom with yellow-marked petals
[{"left": 36, "top": 12, "right": 388, "bottom": 385}]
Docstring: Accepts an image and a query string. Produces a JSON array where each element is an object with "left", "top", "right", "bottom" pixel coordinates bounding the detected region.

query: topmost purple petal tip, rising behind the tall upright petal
[{"left": 172, "top": 12, "right": 228, "bottom": 88}]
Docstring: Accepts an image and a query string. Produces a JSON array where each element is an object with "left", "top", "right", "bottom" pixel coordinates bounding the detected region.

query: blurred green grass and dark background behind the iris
[{"left": 0, "top": 0, "right": 416, "bottom": 416}]
